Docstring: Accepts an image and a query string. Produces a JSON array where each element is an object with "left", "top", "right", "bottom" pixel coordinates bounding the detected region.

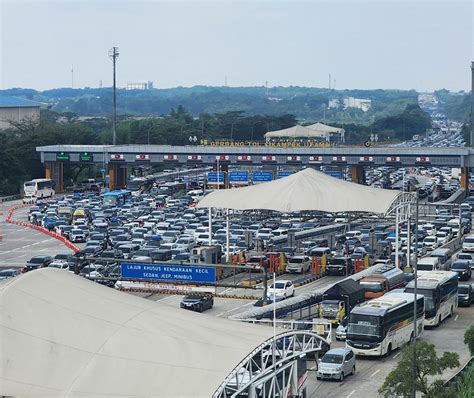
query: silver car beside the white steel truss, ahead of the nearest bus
[{"left": 316, "top": 348, "right": 355, "bottom": 381}]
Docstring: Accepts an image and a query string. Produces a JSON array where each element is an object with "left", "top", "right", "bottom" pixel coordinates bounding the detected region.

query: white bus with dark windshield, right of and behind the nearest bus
[{"left": 405, "top": 271, "right": 458, "bottom": 326}]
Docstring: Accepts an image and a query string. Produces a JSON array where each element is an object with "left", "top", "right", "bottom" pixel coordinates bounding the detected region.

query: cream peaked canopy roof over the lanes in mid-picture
[{"left": 197, "top": 168, "right": 401, "bottom": 214}]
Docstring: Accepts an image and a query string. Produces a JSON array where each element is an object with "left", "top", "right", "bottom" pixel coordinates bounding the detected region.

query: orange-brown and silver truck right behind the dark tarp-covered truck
[{"left": 359, "top": 265, "right": 406, "bottom": 300}]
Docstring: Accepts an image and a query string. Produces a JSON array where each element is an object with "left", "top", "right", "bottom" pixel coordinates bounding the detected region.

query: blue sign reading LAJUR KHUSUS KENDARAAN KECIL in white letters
[{"left": 120, "top": 263, "right": 216, "bottom": 283}]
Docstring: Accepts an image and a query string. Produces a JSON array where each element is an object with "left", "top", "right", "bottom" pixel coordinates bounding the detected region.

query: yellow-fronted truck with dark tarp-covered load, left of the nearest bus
[{"left": 319, "top": 278, "right": 365, "bottom": 323}]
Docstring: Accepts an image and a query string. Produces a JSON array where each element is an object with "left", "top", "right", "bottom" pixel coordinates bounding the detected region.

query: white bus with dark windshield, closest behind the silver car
[{"left": 346, "top": 292, "right": 425, "bottom": 356}]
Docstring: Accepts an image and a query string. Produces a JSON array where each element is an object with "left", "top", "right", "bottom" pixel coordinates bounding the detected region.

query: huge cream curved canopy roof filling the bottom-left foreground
[{"left": 0, "top": 268, "right": 273, "bottom": 397}]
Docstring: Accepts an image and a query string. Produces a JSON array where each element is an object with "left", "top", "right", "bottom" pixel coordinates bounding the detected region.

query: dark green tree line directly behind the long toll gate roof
[{"left": 0, "top": 105, "right": 431, "bottom": 195}]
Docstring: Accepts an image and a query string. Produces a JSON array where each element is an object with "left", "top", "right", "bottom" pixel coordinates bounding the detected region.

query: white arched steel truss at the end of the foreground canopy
[{"left": 213, "top": 330, "right": 327, "bottom": 398}]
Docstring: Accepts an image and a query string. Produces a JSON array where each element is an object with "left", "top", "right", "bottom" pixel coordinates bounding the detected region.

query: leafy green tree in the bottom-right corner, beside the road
[{"left": 379, "top": 341, "right": 459, "bottom": 397}]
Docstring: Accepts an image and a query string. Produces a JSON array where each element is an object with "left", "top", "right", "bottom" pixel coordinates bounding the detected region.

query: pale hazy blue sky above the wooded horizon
[{"left": 0, "top": 0, "right": 474, "bottom": 91}]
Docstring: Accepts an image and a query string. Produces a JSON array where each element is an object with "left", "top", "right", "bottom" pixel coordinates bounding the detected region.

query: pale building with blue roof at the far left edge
[{"left": 0, "top": 95, "right": 43, "bottom": 130}]
